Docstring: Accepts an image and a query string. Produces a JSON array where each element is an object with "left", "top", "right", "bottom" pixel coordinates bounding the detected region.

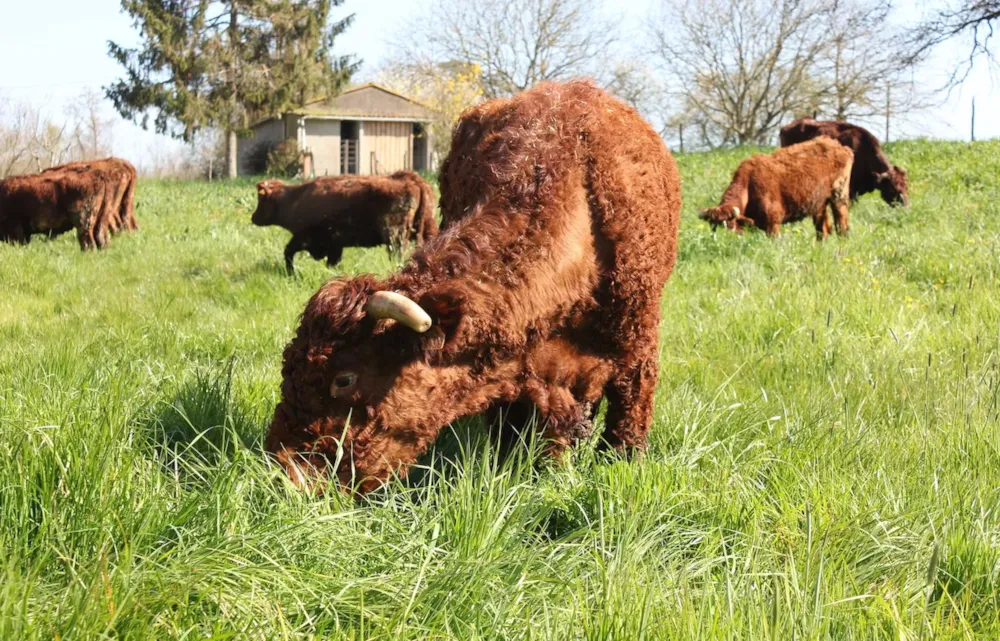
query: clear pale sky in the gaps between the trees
[{"left": 0, "top": 0, "right": 1000, "bottom": 164}]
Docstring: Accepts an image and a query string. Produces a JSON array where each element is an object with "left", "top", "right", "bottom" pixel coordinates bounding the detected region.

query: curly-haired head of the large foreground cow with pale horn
[{"left": 266, "top": 276, "right": 491, "bottom": 493}]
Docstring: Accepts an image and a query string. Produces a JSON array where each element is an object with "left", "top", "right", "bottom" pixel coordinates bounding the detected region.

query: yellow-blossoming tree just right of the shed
[{"left": 378, "top": 59, "right": 483, "bottom": 158}]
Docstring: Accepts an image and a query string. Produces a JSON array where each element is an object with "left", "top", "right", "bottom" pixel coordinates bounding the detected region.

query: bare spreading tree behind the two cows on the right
[{"left": 652, "top": 0, "right": 829, "bottom": 147}]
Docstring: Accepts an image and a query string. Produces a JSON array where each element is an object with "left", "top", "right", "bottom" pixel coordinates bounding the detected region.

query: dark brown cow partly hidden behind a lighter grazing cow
[{"left": 781, "top": 118, "right": 910, "bottom": 207}]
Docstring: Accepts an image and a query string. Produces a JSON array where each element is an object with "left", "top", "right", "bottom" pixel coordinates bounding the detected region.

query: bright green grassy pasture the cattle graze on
[{"left": 0, "top": 141, "right": 1000, "bottom": 641}]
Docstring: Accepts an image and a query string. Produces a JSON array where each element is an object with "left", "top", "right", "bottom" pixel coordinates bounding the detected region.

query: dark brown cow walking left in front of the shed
[{"left": 251, "top": 171, "right": 438, "bottom": 272}]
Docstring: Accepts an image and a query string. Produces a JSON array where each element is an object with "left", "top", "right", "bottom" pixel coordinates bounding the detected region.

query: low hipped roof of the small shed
[{"left": 288, "top": 83, "right": 434, "bottom": 122}]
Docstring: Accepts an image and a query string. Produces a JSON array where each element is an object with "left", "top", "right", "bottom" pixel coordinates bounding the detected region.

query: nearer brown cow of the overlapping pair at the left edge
[{"left": 0, "top": 171, "right": 107, "bottom": 249}]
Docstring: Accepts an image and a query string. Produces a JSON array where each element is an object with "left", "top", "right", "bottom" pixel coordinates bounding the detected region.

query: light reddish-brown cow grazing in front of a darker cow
[{"left": 701, "top": 138, "right": 854, "bottom": 240}]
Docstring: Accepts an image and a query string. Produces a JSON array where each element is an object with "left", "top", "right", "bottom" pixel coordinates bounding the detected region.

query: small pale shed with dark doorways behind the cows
[{"left": 237, "top": 83, "right": 433, "bottom": 177}]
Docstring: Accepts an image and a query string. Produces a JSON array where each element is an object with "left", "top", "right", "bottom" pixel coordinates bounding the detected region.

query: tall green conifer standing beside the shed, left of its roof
[{"left": 105, "top": 0, "right": 358, "bottom": 177}]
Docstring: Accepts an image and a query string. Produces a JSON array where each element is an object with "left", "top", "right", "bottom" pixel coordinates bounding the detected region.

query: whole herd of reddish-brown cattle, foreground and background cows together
[{"left": 0, "top": 81, "right": 908, "bottom": 494}]
